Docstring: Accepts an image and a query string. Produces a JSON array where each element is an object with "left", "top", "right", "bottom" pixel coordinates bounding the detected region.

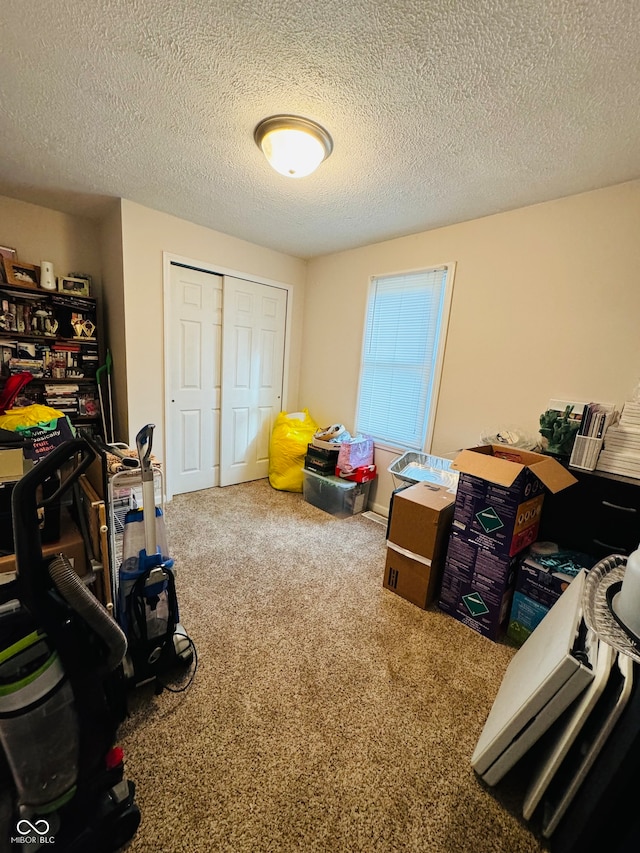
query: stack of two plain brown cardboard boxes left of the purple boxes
[{"left": 383, "top": 483, "right": 455, "bottom": 610}]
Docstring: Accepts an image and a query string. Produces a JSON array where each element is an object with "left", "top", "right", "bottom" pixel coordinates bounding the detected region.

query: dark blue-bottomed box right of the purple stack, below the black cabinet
[{"left": 507, "top": 550, "right": 598, "bottom": 645}]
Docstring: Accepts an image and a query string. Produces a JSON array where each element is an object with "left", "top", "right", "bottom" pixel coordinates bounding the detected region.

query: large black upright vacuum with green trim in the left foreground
[{"left": 0, "top": 439, "right": 140, "bottom": 853}]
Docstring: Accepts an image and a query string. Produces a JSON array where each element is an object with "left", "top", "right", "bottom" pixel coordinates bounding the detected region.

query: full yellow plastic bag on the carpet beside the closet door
[{"left": 269, "top": 409, "right": 318, "bottom": 492}]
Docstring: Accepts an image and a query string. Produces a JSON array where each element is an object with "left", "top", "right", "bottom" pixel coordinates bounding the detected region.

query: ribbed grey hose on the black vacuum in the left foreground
[{"left": 49, "top": 554, "right": 127, "bottom": 671}]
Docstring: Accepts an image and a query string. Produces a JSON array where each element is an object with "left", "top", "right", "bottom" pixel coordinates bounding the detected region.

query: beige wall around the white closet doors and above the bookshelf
[{"left": 0, "top": 196, "right": 306, "bottom": 466}]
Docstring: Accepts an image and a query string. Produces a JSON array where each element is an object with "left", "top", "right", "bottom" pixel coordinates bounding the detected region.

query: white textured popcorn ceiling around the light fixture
[{"left": 0, "top": 0, "right": 640, "bottom": 257}]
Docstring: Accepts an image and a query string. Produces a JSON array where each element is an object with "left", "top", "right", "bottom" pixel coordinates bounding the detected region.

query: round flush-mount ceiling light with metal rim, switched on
[{"left": 253, "top": 115, "right": 333, "bottom": 178}]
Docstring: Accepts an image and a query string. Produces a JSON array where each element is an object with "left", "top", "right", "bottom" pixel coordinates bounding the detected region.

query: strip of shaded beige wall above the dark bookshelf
[{"left": 0, "top": 196, "right": 101, "bottom": 296}]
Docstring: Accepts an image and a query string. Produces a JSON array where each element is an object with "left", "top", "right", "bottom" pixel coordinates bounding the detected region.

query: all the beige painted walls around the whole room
[{"left": 6, "top": 181, "right": 640, "bottom": 510}]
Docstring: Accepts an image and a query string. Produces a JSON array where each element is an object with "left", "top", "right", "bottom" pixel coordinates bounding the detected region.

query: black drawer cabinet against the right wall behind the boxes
[{"left": 539, "top": 468, "right": 640, "bottom": 558}]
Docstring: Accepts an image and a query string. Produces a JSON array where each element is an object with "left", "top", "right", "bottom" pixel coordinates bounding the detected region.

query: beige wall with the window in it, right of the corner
[{"left": 300, "top": 181, "right": 640, "bottom": 510}]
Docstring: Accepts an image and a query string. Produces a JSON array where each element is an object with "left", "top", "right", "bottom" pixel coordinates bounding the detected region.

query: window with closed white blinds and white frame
[{"left": 356, "top": 264, "right": 453, "bottom": 450}]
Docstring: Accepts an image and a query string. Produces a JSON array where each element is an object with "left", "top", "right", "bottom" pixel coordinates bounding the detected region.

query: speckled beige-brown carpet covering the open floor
[{"left": 120, "top": 480, "right": 543, "bottom": 853}]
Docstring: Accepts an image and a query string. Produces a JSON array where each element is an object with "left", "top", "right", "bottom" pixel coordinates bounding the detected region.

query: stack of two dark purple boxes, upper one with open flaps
[{"left": 439, "top": 445, "right": 576, "bottom": 640}]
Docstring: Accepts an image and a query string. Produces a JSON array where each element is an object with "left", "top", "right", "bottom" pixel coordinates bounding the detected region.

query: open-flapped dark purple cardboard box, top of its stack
[{"left": 452, "top": 445, "right": 577, "bottom": 557}]
